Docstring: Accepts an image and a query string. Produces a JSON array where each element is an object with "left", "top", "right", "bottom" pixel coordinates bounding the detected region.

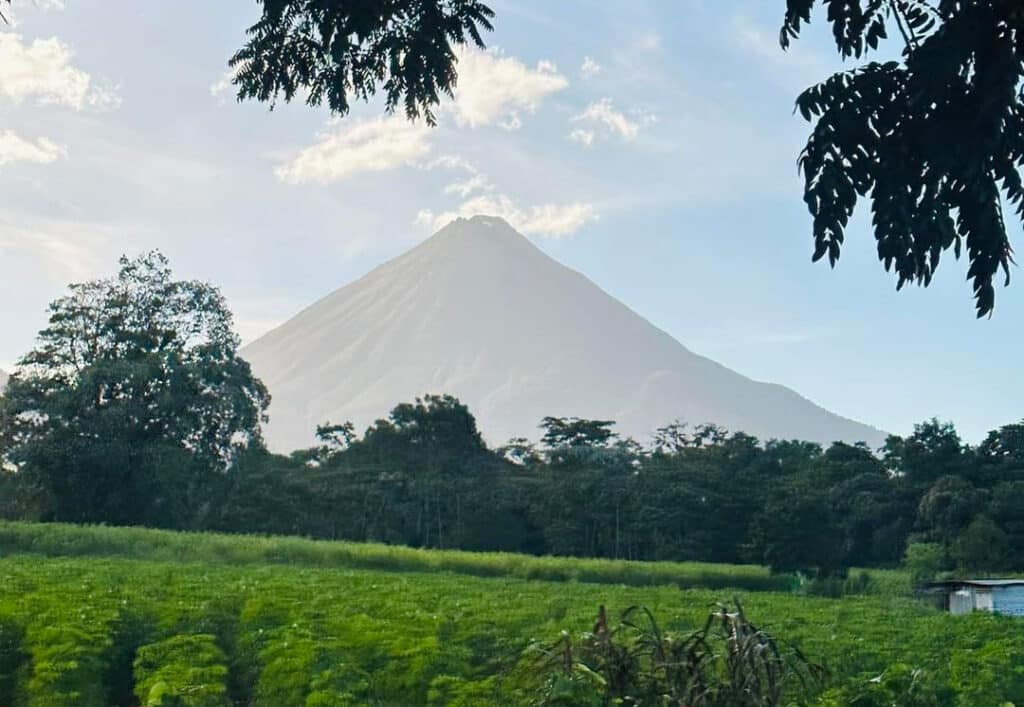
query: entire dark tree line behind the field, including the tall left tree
[{"left": 0, "top": 253, "right": 1024, "bottom": 576}]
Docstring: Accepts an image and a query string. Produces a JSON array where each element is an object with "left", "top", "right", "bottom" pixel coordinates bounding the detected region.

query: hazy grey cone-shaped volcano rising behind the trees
[{"left": 243, "top": 216, "right": 884, "bottom": 450}]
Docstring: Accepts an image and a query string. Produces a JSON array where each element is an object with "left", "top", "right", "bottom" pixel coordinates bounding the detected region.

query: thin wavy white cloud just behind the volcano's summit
[{"left": 416, "top": 195, "right": 597, "bottom": 239}]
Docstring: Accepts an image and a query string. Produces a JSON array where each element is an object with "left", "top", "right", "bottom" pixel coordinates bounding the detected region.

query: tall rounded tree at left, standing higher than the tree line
[{"left": 0, "top": 252, "right": 269, "bottom": 525}]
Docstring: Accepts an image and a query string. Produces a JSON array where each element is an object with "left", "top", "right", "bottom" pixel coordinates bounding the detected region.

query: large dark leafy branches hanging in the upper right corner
[{"left": 780, "top": 0, "right": 1024, "bottom": 317}]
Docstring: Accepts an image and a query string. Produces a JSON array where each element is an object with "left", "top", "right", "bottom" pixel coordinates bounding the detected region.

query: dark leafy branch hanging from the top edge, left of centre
[{"left": 230, "top": 0, "right": 495, "bottom": 125}]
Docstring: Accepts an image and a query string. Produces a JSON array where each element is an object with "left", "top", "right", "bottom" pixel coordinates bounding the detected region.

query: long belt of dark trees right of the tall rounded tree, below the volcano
[{"left": 201, "top": 398, "right": 1024, "bottom": 578}]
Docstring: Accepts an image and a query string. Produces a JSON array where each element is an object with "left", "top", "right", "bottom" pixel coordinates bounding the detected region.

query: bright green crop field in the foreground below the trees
[{"left": 0, "top": 524, "right": 1024, "bottom": 707}]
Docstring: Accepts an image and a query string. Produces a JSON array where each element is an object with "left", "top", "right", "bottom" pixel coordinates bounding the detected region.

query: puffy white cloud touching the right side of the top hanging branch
[{"left": 449, "top": 49, "right": 569, "bottom": 130}]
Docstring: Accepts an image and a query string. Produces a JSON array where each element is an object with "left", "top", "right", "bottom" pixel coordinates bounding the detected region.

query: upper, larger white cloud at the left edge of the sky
[{"left": 0, "top": 33, "right": 118, "bottom": 110}]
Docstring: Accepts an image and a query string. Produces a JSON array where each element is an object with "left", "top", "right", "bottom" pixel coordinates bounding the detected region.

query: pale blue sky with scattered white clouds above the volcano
[{"left": 0, "top": 0, "right": 1024, "bottom": 442}]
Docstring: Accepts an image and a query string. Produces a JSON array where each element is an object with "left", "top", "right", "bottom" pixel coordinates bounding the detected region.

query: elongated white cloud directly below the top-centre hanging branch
[{"left": 274, "top": 116, "right": 431, "bottom": 184}]
